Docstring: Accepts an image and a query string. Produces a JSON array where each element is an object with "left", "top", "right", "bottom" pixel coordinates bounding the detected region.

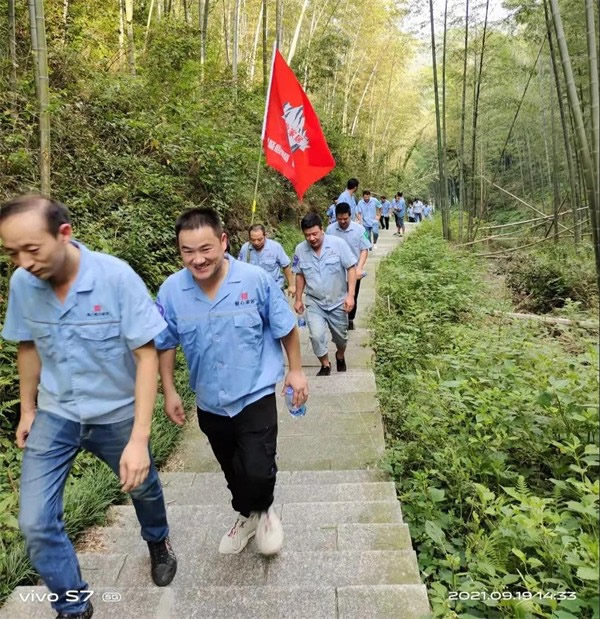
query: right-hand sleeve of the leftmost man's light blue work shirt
[{"left": 119, "top": 266, "right": 167, "bottom": 350}]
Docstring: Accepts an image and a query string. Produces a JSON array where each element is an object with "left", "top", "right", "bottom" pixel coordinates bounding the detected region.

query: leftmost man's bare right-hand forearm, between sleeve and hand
[{"left": 130, "top": 344, "right": 158, "bottom": 442}]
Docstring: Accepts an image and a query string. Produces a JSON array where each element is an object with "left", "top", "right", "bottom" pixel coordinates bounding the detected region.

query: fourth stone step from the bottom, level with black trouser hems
[{"left": 109, "top": 500, "right": 402, "bottom": 530}]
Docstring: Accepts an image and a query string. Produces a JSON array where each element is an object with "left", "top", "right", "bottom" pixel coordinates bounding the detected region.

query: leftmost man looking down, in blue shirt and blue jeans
[{"left": 0, "top": 195, "right": 177, "bottom": 619}]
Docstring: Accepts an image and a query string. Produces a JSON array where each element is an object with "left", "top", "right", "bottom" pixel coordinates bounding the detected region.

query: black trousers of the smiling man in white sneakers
[{"left": 198, "top": 394, "right": 277, "bottom": 517}]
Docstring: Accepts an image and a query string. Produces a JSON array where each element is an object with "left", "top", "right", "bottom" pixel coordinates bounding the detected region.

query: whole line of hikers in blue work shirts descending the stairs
[{"left": 0, "top": 179, "right": 428, "bottom": 619}]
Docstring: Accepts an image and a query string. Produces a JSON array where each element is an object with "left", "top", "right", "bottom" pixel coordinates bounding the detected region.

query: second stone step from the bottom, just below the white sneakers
[{"left": 59, "top": 541, "right": 420, "bottom": 591}]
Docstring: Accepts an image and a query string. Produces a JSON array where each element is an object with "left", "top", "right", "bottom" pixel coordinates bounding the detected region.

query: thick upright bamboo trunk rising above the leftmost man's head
[{"left": 32, "top": 0, "right": 50, "bottom": 196}]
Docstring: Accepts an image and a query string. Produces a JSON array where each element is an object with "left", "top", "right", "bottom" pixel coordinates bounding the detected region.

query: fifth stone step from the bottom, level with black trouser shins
[{"left": 158, "top": 478, "right": 396, "bottom": 505}]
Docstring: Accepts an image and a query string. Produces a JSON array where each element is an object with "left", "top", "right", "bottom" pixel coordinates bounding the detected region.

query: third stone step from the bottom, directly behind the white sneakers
[{"left": 98, "top": 515, "right": 412, "bottom": 556}]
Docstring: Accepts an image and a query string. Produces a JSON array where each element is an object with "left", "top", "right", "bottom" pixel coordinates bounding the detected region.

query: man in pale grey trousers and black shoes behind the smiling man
[{"left": 292, "top": 213, "right": 357, "bottom": 376}]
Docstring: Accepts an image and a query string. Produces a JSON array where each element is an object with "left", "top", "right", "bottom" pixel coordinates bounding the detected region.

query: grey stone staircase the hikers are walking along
[{"left": 0, "top": 230, "right": 429, "bottom": 619}]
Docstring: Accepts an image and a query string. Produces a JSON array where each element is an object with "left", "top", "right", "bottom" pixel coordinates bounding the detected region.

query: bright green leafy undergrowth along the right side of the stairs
[{"left": 375, "top": 224, "right": 599, "bottom": 618}]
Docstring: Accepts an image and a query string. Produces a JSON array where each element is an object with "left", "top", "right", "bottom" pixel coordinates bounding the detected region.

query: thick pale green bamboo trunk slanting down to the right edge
[{"left": 549, "top": 0, "right": 600, "bottom": 290}]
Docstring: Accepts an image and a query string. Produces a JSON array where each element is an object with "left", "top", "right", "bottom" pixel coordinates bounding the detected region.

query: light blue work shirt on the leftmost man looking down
[{"left": 2, "top": 241, "right": 166, "bottom": 424}]
